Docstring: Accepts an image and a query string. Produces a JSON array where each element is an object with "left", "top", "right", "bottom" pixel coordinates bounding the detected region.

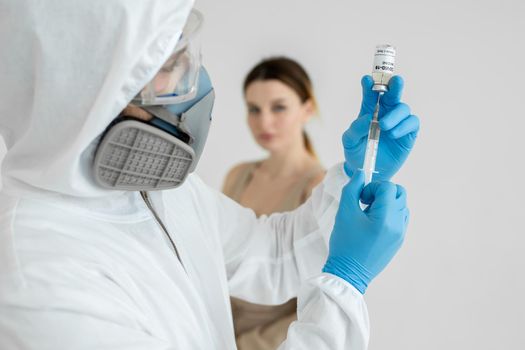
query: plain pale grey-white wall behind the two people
[{"left": 196, "top": 0, "right": 525, "bottom": 350}]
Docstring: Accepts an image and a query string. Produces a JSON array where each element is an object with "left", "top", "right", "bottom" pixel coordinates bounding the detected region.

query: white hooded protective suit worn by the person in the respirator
[{"left": 0, "top": 0, "right": 368, "bottom": 350}]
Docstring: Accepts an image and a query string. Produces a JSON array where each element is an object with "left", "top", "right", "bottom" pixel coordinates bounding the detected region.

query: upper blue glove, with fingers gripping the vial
[{"left": 343, "top": 75, "right": 419, "bottom": 181}]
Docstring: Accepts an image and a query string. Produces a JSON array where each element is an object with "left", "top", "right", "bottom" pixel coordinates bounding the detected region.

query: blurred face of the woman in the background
[{"left": 245, "top": 80, "right": 314, "bottom": 152}]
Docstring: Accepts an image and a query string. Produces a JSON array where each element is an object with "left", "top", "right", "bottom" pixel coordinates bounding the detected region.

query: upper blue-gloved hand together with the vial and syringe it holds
[{"left": 343, "top": 45, "right": 419, "bottom": 184}]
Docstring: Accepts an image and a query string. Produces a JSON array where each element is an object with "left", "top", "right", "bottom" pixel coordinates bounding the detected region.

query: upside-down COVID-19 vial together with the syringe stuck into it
[{"left": 363, "top": 45, "right": 396, "bottom": 184}]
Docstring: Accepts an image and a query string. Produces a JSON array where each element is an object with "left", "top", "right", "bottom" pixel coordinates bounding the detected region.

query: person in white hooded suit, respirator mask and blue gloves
[{"left": 0, "top": 0, "right": 417, "bottom": 350}]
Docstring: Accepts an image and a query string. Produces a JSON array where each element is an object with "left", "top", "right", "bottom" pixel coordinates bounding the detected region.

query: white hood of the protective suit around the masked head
[{"left": 0, "top": 0, "right": 193, "bottom": 197}]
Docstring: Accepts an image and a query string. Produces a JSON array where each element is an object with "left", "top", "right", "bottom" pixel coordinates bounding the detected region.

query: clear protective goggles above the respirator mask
[{"left": 133, "top": 10, "right": 203, "bottom": 106}]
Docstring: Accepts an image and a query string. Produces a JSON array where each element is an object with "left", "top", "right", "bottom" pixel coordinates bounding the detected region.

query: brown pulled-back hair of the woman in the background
[{"left": 243, "top": 57, "right": 318, "bottom": 158}]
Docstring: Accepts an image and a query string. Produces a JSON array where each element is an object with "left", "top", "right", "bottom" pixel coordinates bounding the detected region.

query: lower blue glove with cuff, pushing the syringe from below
[{"left": 323, "top": 170, "right": 409, "bottom": 294}]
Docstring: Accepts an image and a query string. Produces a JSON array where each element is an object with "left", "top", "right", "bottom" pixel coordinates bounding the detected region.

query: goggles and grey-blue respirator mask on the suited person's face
[{"left": 93, "top": 10, "right": 215, "bottom": 191}]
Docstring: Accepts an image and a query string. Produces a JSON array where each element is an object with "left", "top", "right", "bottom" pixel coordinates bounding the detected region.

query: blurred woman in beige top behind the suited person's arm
[{"left": 223, "top": 57, "right": 325, "bottom": 350}]
